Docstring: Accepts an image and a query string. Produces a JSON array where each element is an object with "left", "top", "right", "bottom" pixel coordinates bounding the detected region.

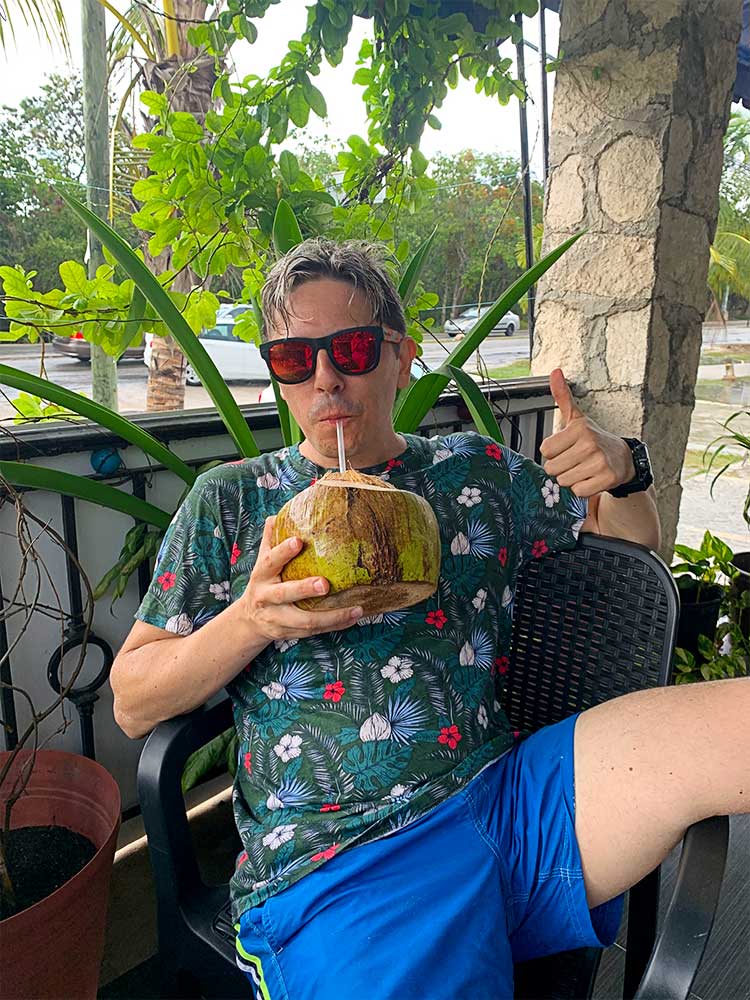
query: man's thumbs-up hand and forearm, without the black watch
[{"left": 540, "top": 368, "right": 661, "bottom": 549}]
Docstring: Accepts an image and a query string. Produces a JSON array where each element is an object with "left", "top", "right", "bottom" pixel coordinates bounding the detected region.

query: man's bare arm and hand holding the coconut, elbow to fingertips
[{"left": 110, "top": 517, "right": 362, "bottom": 739}]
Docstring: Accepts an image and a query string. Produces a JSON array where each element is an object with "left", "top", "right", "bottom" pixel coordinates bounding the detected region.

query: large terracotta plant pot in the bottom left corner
[{"left": 0, "top": 750, "right": 120, "bottom": 1000}]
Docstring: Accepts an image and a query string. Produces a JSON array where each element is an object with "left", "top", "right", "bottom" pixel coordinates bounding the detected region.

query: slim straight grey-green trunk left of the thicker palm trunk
[{"left": 81, "top": 0, "right": 117, "bottom": 410}]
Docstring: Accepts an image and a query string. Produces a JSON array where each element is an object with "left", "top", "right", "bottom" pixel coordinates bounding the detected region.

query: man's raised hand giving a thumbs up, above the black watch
[{"left": 540, "top": 368, "right": 635, "bottom": 497}]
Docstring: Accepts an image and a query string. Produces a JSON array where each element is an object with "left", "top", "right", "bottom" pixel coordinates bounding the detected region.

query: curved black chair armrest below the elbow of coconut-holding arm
[{"left": 138, "top": 698, "right": 232, "bottom": 908}]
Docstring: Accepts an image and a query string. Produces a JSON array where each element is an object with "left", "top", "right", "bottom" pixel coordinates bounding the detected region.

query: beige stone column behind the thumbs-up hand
[{"left": 532, "top": 0, "right": 742, "bottom": 557}]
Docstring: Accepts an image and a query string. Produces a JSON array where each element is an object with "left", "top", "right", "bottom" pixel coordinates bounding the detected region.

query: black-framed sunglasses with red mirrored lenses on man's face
[{"left": 260, "top": 326, "right": 404, "bottom": 385}]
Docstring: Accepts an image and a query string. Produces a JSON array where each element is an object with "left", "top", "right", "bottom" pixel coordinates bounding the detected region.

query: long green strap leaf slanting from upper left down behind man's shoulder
[{"left": 58, "top": 191, "right": 260, "bottom": 457}]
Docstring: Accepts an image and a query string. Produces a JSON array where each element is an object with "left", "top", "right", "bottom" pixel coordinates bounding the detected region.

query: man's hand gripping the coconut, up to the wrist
[{"left": 239, "top": 517, "right": 363, "bottom": 642}]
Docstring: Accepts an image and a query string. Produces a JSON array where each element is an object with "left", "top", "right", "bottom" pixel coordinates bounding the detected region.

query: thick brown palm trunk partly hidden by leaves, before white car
[{"left": 144, "top": 0, "right": 216, "bottom": 410}]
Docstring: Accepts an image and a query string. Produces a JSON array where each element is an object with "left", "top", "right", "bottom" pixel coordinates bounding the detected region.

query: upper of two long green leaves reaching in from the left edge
[{"left": 0, "top": 364, "right": 195, "bottom": 486}]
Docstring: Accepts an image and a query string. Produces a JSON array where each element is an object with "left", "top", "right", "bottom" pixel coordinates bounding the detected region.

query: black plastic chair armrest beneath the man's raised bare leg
[{"left": 635, "top": 816, "right": 729, "bottom": 1000}]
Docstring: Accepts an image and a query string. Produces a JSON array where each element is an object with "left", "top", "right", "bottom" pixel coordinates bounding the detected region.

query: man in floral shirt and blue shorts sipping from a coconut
[{"left": 112, "top": 240, "right": 750, "bottom": 1000}]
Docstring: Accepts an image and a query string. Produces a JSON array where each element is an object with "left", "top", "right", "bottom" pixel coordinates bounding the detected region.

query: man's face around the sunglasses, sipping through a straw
[{"left": 272, "top": 278, "right": 416, "bottom": 468}]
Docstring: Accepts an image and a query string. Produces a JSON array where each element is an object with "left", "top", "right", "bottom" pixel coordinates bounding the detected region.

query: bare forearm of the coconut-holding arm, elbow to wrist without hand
[{"left": 111, "top": 602, "right": 268, "bottom": 739}]
